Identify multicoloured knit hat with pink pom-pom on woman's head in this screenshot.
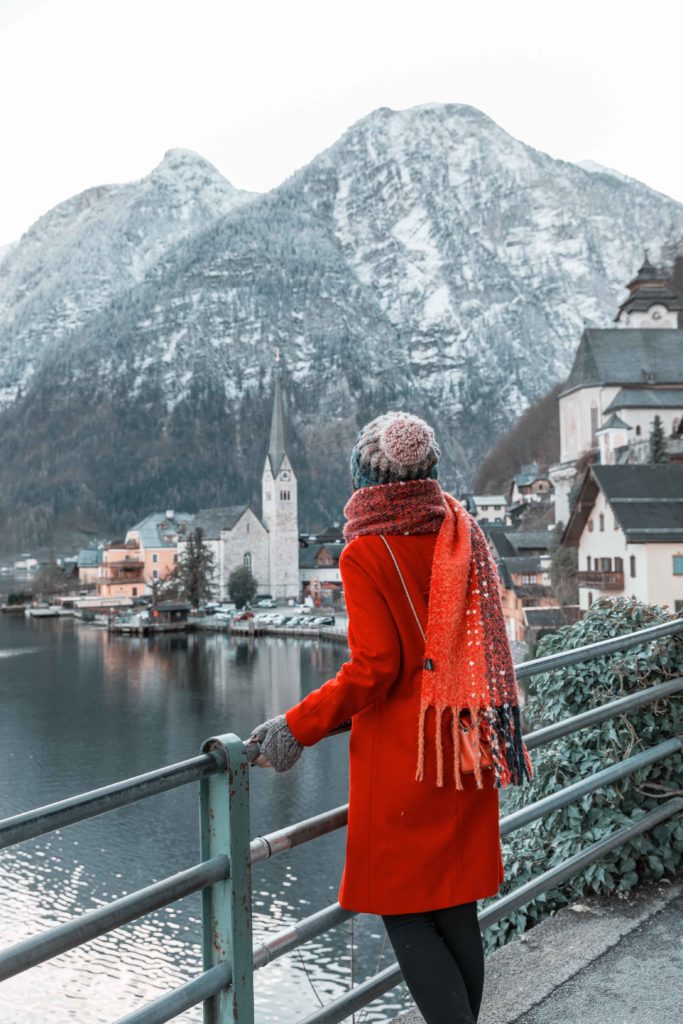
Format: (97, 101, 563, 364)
(350, 412, 440, 489)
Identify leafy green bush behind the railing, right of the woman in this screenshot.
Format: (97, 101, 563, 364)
(487, 598, 683, 946)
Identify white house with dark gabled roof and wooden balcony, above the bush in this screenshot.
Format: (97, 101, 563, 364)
(562, 463, 683, 611)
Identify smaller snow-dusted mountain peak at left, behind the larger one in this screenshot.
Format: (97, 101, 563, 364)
(0, 150, 252, 407)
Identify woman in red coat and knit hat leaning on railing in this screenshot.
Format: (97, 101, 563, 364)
(251, 413, 530, 1024)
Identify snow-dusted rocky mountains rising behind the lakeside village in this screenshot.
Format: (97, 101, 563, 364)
(0, 105, 683, 550)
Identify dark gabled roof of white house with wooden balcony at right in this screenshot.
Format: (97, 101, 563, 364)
(564, 463, 683, 544)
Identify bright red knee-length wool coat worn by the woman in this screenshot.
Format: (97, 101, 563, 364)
(286, 534, 503, 914)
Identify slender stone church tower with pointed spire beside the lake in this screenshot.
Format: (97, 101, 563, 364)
(261, 350, 299, 599)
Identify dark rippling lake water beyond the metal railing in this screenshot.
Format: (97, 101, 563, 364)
(0, 615, 410, 1024)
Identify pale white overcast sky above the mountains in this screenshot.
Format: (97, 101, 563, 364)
(0, 0, 683, 244)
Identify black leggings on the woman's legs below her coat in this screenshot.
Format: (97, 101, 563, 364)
(382, 902, 483, 1024)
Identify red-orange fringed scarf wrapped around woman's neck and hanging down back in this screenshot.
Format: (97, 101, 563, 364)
(344, 480, 532, 790)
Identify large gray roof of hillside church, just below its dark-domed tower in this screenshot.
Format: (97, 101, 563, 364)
(562, 328, 683, 394)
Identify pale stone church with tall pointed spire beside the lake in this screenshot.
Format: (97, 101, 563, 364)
(178, 356, 299, 600)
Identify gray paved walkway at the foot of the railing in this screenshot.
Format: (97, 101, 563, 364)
(396, 876, 683, 1024)
